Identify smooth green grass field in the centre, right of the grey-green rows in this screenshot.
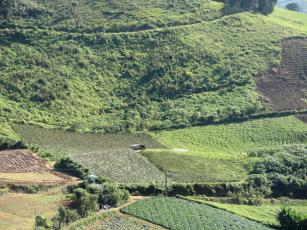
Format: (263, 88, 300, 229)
(142, 150, 250, 183)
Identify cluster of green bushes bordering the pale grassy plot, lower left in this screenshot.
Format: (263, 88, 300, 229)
(35, 177, 130, 229)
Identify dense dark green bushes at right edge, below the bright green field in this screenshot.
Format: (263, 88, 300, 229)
(248, 146, 307, 199)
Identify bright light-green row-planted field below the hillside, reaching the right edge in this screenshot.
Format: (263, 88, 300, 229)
(153, 116, 307, 157)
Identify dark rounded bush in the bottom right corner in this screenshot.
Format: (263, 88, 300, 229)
(278, 208, 307, 230)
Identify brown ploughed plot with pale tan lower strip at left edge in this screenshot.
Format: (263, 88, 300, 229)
(0, 150, 66, 184)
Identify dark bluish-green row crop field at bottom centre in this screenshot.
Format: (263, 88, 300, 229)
(122, 198, 270, 230)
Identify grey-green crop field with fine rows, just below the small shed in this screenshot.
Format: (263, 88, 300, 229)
(71, 150, 164, 183)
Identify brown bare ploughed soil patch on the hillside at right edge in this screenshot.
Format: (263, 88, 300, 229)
(256, 38, 307, 112)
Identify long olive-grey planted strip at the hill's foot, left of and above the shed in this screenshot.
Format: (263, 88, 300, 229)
(13, 125, 164, 157)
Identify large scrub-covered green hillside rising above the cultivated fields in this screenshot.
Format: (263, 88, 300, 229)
(0, 0, 307, 137)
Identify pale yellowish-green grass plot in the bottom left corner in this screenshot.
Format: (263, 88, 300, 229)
(0, 189, 65, 230)
